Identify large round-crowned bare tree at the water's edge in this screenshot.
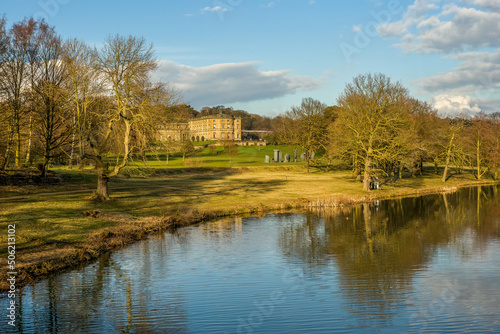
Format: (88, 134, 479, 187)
(336, 74, 412, 191)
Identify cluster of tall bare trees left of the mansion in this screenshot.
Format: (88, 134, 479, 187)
(0, 18, 180, 199)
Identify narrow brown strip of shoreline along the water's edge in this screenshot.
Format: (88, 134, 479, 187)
(0, 171, 499, 293)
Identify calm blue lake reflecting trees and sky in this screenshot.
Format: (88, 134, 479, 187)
(0, 187, 500, 333)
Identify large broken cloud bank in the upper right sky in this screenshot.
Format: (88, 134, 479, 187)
(377, 0, 500, 116)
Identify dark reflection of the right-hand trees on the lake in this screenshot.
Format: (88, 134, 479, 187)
(280, 187, 500, 329)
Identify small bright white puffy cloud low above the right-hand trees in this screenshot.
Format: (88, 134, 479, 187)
(432, 94, 481, 117)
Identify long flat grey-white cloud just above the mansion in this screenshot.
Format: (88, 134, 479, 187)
(155, 60, 324, 107)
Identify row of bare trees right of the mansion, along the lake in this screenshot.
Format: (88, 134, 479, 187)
(273, 73, 500, 191)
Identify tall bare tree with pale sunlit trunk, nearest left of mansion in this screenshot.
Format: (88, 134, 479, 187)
(85, 35, 160, 200)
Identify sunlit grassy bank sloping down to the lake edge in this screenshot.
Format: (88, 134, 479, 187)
(0, 164, 496, 290)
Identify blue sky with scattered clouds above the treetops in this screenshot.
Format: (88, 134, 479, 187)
(0, 0, 500, 117)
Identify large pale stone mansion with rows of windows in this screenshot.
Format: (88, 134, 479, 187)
(159, 114, 241, 141)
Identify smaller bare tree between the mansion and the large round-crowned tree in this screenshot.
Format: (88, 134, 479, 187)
(282, 98, 327, 173)
